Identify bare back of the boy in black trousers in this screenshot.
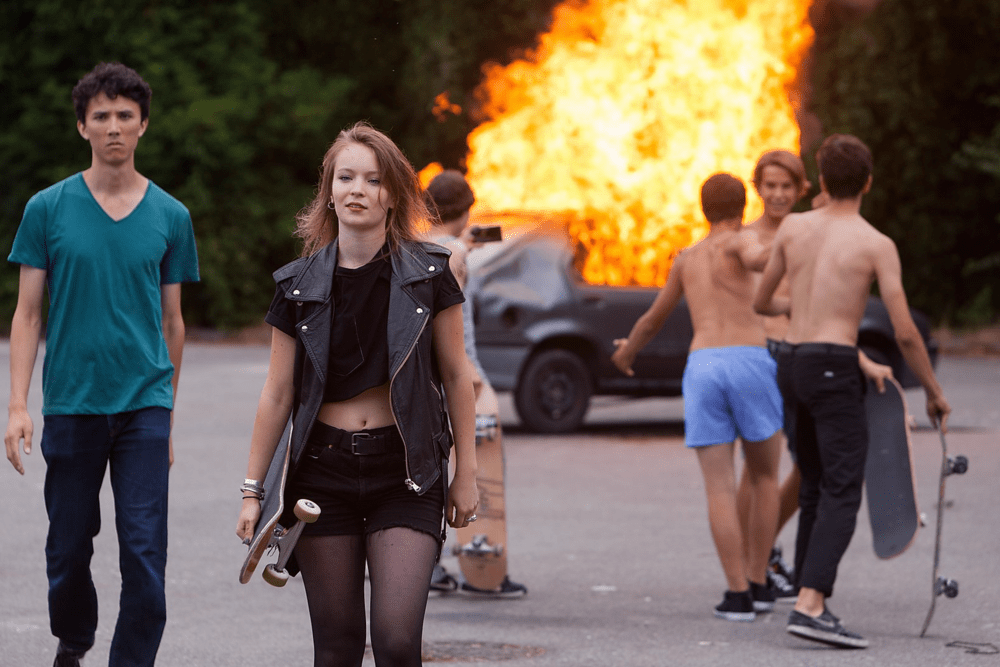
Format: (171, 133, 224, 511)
(777, 206, 894, 345)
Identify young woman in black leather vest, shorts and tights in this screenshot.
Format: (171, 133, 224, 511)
(236, 123, 479, 667)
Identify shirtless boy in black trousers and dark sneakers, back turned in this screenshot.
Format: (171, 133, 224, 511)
(754, 135, 951, 648)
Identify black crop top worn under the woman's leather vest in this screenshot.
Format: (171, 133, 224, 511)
(265, 244, 465, 403)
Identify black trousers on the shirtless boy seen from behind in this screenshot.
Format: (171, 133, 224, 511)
(778, 343, 868, 597)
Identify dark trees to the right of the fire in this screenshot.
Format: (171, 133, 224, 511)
(812, 0, 1000, 324)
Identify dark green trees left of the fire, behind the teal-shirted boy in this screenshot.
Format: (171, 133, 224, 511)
(0, 0, 556, 329)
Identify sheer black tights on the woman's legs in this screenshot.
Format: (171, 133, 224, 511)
(295, 527, 438, 667)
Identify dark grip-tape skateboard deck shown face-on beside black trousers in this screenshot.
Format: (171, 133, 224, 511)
(865, 379, 920, 558)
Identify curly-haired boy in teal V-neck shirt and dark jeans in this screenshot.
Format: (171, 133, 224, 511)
(4, 63, 198, 666)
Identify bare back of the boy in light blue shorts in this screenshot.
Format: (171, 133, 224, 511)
(678, 228, 766, 350)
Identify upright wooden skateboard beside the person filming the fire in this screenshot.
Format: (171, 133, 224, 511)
(453, 385, 507, 590)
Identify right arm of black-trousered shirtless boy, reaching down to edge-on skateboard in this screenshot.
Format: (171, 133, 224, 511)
(873, 238, 951, 432)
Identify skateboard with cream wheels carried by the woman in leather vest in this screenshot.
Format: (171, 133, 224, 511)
(240, 421, 320, 586)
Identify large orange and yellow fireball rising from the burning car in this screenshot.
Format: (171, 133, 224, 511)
(467, 0, 813, 285)
